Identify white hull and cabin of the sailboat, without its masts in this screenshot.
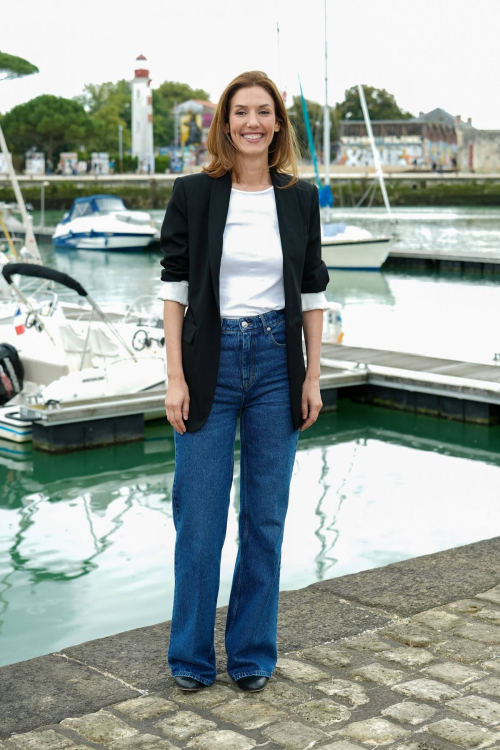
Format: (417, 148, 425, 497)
(321, 222, 392, 271)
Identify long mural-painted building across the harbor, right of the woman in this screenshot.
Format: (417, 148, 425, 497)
(334, 108, 475, 170)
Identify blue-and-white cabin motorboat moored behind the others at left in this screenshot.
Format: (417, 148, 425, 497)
(52, 195, 159, 250)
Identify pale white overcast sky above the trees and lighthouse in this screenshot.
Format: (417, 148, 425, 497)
(0, 0, 500, 129)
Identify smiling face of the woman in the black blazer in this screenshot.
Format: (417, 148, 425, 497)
(225, 86, 280, 155)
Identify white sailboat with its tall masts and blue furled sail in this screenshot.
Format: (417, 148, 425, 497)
(299, 0, 392, 271)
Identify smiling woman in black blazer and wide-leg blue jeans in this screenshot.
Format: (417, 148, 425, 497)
(159, 71, 329, 691)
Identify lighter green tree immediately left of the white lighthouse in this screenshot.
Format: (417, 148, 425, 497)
(74, 79, 132, 152)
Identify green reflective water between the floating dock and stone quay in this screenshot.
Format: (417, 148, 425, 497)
(0, 401, 500, 664)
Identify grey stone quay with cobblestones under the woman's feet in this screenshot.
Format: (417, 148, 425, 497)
(0, 537, 500, 750)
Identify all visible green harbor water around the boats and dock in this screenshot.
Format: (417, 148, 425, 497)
(0, 208, 500, 665)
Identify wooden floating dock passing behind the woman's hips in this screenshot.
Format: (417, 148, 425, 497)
(9, 343, 500, 453)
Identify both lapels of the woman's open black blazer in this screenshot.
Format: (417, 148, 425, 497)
(208, 168, 303, 310)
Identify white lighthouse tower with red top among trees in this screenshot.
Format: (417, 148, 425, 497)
(132, 55, 155, 173)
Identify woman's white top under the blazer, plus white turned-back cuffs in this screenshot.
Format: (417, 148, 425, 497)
(158, 186, 328, 318)
